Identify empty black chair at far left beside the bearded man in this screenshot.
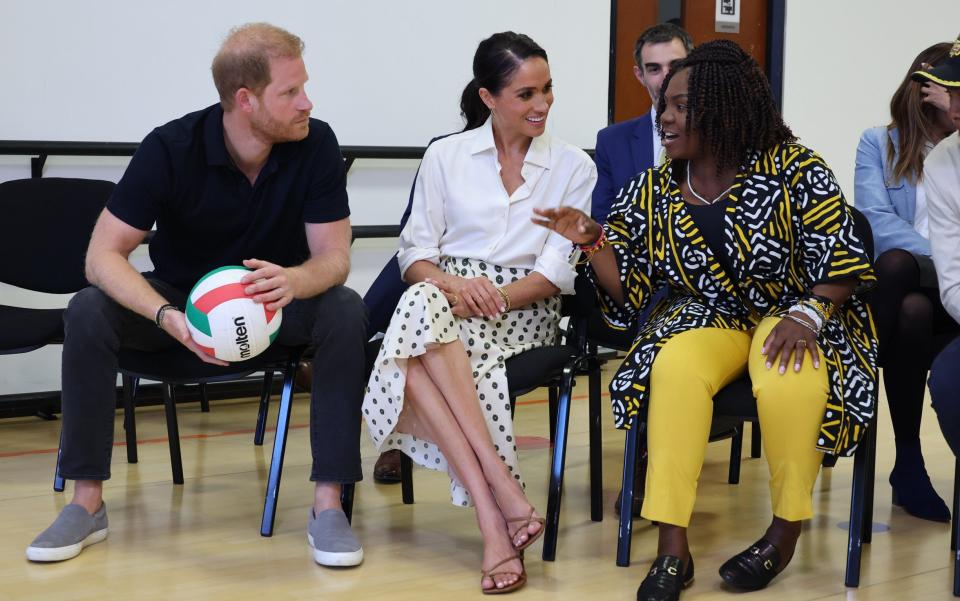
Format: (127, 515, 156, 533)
(0, 178, 114, 355)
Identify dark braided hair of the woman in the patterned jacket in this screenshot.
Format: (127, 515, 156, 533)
(657, 40, 797, 170)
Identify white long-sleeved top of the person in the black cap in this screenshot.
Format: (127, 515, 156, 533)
(923, 132, 960, 321)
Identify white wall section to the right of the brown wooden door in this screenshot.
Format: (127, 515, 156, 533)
(783, 0, 960, 203)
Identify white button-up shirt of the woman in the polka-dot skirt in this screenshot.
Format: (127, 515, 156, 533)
(397, 119, 597, 294)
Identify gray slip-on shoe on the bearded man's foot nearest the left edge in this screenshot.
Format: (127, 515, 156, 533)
(27, 503, 107, 561)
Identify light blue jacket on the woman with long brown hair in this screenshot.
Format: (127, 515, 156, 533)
(853, 127, 931, 257)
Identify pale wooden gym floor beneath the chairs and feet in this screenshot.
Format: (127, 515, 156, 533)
(0, 365, 953, 601)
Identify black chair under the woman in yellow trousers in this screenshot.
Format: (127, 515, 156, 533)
(617, 207, 876, 587)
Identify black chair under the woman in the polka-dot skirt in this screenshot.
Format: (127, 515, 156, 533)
(388, 276, 603, 561)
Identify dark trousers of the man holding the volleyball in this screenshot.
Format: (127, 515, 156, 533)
(60, 276, 367, 482)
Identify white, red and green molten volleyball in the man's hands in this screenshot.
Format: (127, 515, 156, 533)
(186, 265, 281, 361)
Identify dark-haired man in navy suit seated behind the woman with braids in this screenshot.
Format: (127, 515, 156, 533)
(590, 23, 693, 223)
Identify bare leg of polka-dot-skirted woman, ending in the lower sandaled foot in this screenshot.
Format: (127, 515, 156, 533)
(397, 357, 523, 588)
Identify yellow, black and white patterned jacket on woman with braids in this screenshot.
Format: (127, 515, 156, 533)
(598, 144, 877, 455)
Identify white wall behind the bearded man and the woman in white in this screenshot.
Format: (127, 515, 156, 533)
(0, 0, 610, 395)
